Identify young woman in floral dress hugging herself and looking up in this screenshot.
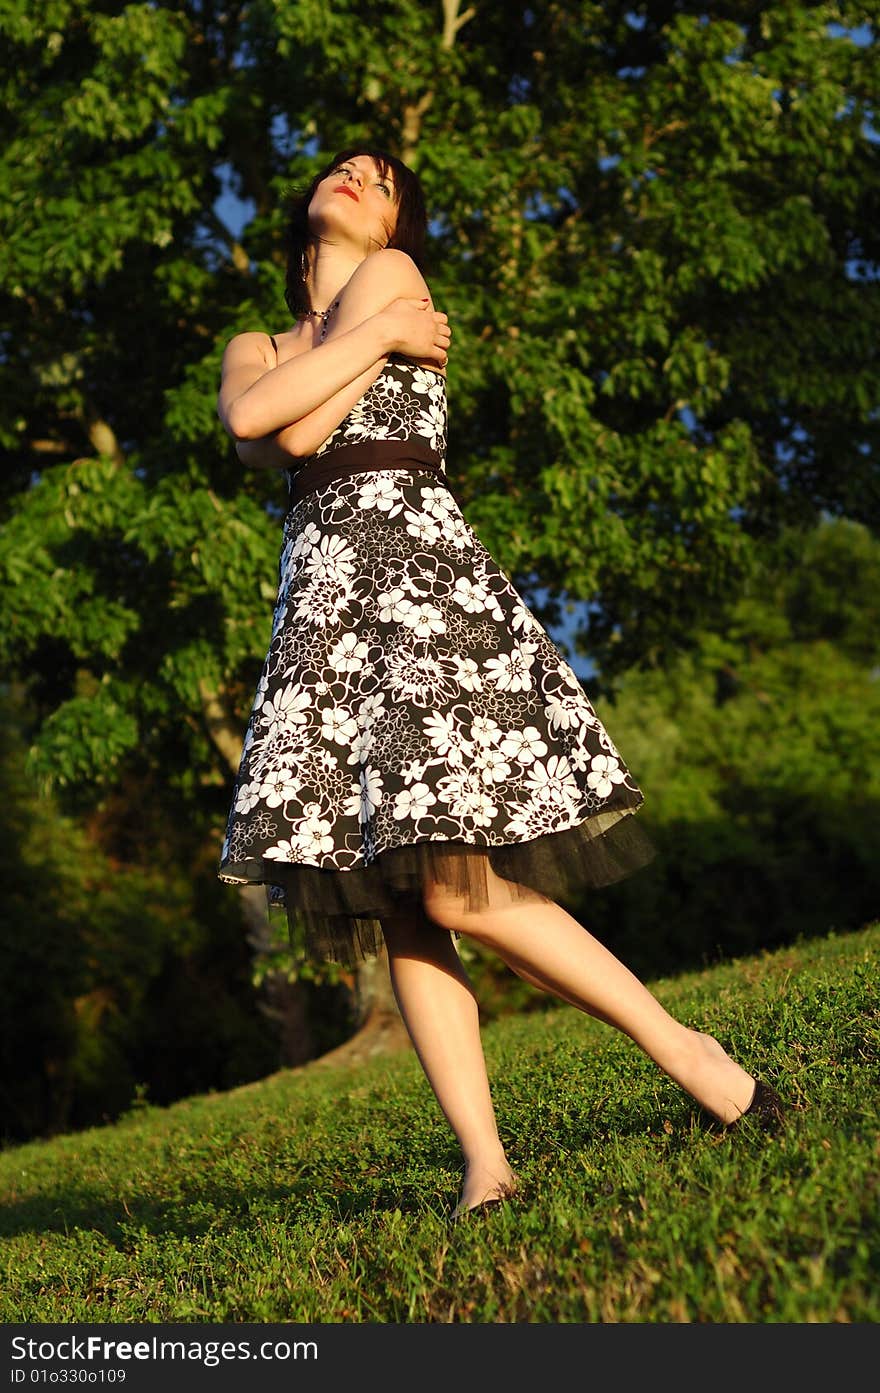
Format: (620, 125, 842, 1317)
(219, 148, 783, 1216)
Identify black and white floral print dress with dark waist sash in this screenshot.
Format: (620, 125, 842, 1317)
(219, 355, 654, 964)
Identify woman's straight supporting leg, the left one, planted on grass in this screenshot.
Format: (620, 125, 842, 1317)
(382, 910, 515, 1213)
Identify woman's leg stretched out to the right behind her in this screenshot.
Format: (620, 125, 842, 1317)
(425, 866, 755, 1123)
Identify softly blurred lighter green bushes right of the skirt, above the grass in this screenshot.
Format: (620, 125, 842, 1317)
(576, 521, 880, 972)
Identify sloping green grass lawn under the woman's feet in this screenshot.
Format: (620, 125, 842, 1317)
(0, 926, 880, 1323)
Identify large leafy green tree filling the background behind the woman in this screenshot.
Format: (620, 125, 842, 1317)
(0, 0, 880, 1058)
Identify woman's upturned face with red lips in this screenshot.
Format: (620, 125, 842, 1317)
(309, 155, 397, 255)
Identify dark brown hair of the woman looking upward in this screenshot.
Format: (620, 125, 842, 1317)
(284, 145, 427, 318)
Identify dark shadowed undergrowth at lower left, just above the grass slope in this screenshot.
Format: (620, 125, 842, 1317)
(0, 694, 277, 1142)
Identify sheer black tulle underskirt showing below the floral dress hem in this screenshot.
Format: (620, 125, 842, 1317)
(223, 795, 656, 967)
